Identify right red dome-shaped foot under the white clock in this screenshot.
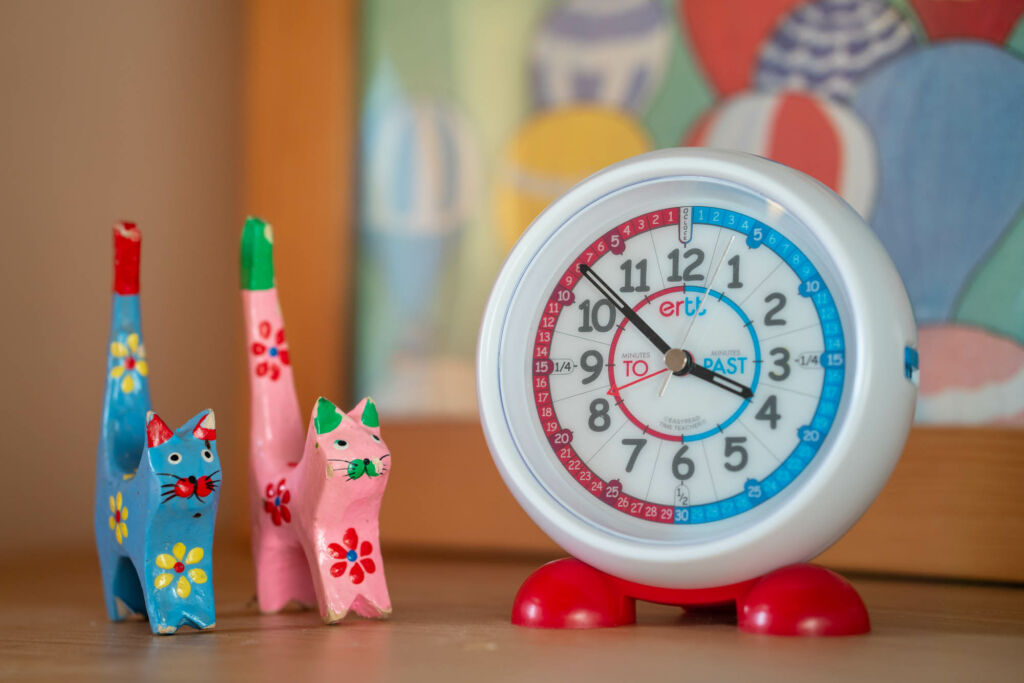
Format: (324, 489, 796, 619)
(736, 564, 871, 636)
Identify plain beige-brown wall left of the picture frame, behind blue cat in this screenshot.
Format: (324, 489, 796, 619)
(0, 0, 245, 557)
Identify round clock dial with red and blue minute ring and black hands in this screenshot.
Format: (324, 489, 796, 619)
(530, 205, 845, 524)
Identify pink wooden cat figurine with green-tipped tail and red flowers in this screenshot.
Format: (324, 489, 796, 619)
(241, 218, 391, 624)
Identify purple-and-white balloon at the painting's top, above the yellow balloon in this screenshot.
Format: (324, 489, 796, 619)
(529, 0, 673, 112)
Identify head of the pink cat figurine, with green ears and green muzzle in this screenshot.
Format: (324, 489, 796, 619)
(313, 396, 391, 481)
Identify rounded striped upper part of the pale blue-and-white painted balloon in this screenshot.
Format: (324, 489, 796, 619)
(362, 99, 480, 236)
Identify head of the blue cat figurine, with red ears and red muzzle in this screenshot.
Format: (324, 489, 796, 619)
(145, 411, 220, 509)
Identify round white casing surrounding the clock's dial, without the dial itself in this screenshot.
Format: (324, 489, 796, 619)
(477, 148, 916, 589)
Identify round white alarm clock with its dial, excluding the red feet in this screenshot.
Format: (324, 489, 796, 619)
(477, 148, 916, 589)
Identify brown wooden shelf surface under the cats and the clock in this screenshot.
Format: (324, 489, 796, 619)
(0, 548, 1024, 683)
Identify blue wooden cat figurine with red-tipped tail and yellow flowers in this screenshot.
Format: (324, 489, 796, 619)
(95, 223, 220, 634)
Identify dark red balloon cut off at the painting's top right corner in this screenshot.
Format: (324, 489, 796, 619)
(910, 0, 1024, 45)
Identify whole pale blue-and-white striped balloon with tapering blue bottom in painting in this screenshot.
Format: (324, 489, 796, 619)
(361, 98, 481, 345)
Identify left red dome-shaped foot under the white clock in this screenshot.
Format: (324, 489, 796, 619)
(512, 558, 636, 629)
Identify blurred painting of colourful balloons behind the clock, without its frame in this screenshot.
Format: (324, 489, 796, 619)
(354, 0, 1024, 425)
